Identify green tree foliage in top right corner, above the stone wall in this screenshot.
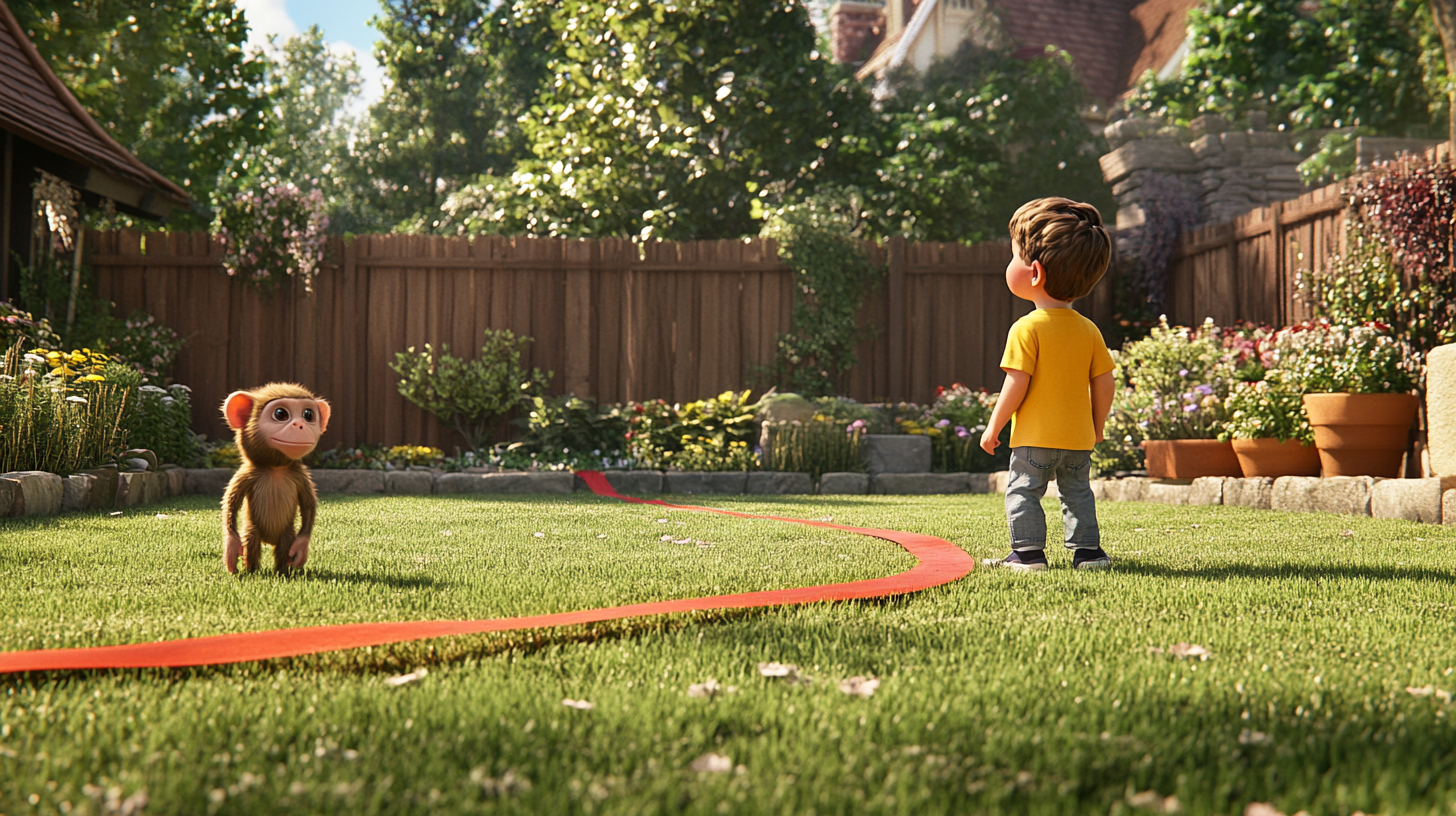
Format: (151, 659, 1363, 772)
(1130, 0, 1447, 136)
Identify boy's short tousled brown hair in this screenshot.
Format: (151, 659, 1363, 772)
(1010, 197, 1112, 300)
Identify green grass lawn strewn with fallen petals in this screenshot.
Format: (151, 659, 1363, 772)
(0, 494, 1456, 816)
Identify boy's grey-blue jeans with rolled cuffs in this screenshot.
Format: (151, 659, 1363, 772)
(1006, 446, 1102, 551)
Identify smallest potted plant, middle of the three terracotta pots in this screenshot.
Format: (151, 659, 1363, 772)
(1219, 369, 1319, 478)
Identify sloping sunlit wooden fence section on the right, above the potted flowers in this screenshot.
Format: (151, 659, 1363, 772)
(1166, 143, 1450, 326)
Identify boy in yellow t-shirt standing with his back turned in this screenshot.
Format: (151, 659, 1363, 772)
(981, 198, 1112, 570)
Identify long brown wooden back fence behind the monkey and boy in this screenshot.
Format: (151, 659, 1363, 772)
(84, 232, 1111, 450)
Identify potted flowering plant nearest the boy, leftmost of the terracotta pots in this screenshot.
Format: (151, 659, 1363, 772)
(1108, 318, 1241, 479)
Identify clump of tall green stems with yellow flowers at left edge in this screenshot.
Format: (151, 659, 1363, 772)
(0, 341, 128, 475)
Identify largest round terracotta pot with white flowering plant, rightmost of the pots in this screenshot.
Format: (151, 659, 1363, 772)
(1273, 321, 1420, 476)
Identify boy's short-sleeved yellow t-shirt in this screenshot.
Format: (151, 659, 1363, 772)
(1000, 309, 1112, 450)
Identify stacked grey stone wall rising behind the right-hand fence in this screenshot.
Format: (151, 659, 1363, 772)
(1102, 115, 1318, 230)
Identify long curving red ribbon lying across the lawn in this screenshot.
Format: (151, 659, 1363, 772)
(0, 471, 976, 673)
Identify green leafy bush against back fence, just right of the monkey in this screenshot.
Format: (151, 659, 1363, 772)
(390, 329, 550, 450)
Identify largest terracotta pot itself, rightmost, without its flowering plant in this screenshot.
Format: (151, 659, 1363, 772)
(1305, 393, 1420, 478)
